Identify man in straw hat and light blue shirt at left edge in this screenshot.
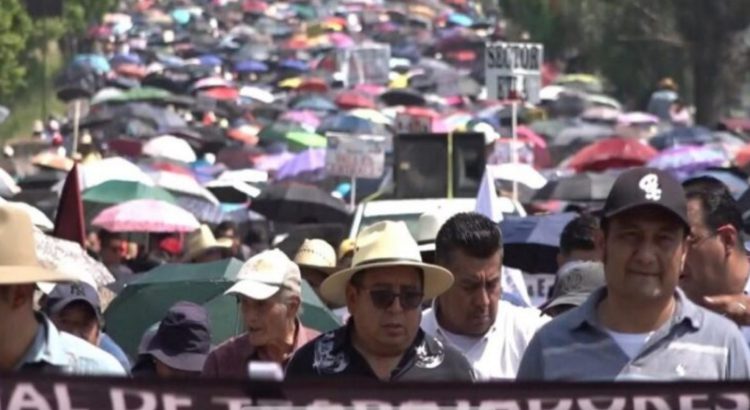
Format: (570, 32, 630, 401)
(0, 206, 125, 375)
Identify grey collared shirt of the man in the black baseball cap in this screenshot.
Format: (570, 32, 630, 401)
(518, 288, 750, 381)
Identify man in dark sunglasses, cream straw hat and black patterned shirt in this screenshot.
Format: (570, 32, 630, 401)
(286, 221, 474, 381)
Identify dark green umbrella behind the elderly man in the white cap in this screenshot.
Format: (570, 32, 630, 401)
(104, 259, 242, 356)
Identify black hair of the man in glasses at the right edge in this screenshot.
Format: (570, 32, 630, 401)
(682, 176, 743, 246)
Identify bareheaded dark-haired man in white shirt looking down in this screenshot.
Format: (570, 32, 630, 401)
(422, 213, 549, 380)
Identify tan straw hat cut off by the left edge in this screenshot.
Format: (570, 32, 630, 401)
(0, 204, 76, 285)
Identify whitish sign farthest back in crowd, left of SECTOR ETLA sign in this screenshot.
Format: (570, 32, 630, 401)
(336, 43, 391, 87)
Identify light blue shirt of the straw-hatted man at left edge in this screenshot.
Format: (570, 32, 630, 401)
(16, 313, 127, 376)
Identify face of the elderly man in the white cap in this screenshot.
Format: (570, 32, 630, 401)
(240, 293, 297, 347)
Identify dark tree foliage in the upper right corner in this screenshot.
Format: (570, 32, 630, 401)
(500, 0, 750, 124)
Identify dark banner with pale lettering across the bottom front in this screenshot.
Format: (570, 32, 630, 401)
(0, 374, 750, 410)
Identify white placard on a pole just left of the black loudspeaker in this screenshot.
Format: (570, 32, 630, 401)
(326, 133, 386, 178)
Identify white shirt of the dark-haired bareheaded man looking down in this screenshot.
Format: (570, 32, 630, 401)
(421, 301, 550, 380)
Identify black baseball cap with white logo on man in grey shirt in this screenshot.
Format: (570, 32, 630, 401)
(602, 167, 690, 232)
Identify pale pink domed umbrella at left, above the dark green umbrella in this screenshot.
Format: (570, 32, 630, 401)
(91, 199, 200, 232)
